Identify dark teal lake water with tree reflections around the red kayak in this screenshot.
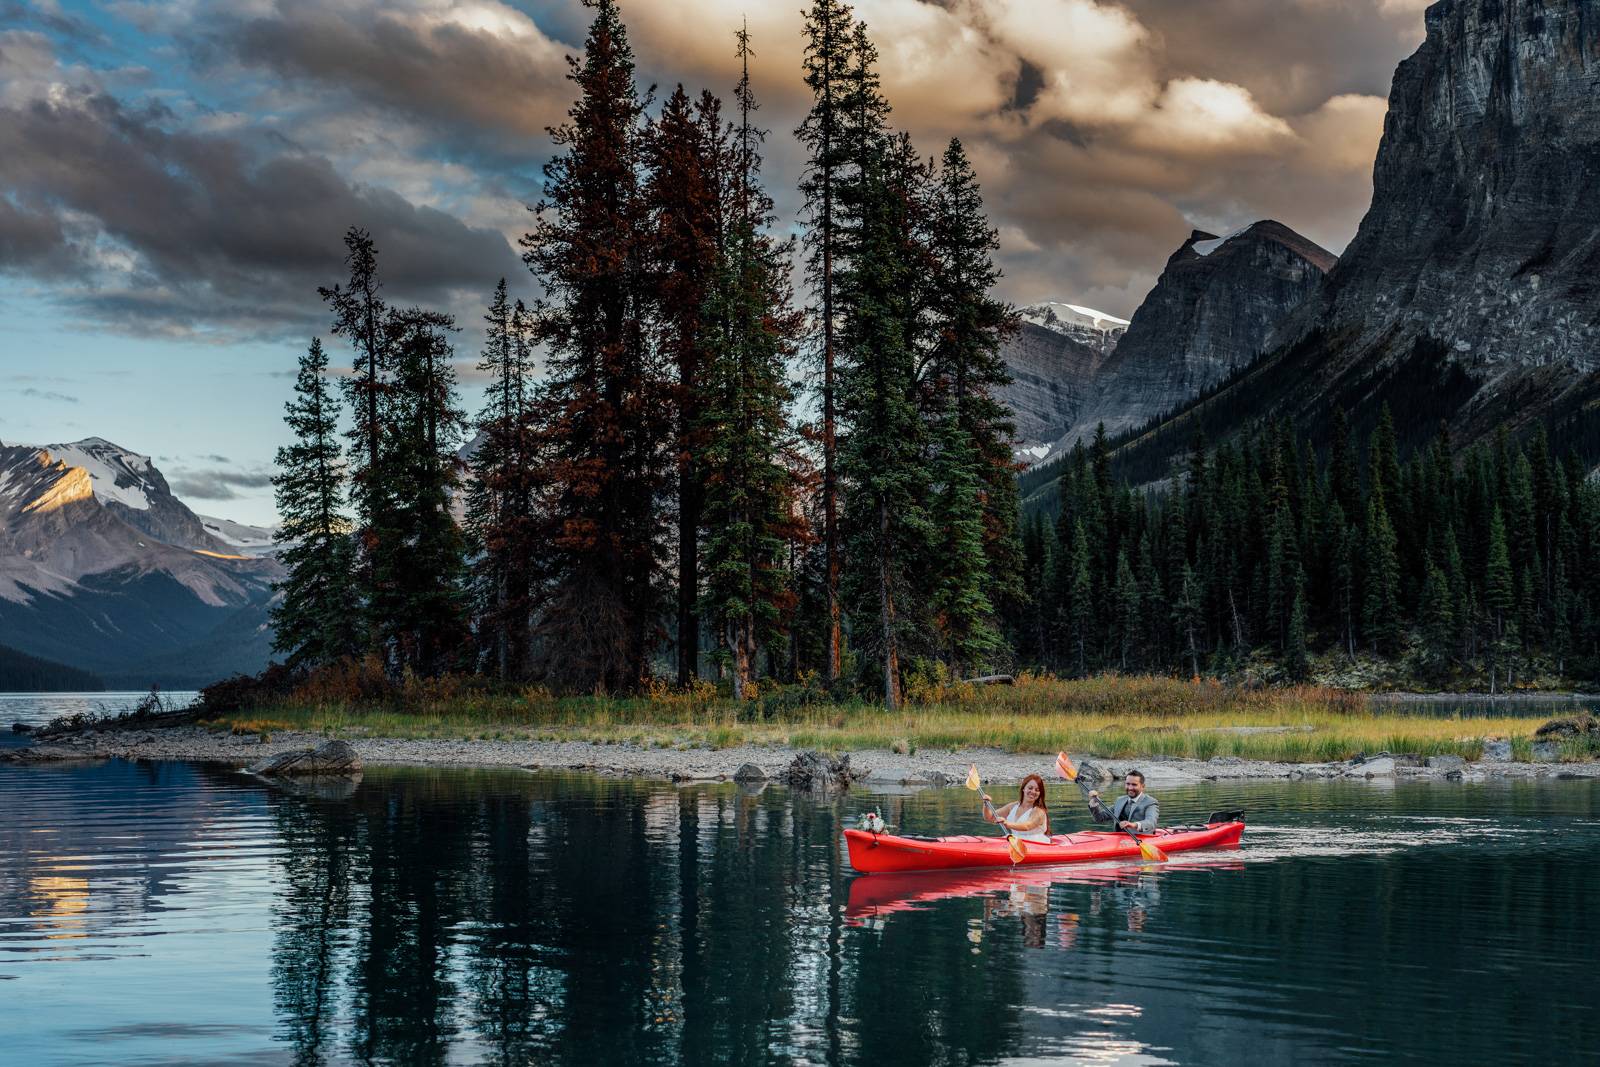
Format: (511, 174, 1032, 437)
(0, 700, 1600, 1065)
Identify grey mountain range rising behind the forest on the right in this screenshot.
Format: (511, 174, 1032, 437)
(1006, 0, 1600, 483)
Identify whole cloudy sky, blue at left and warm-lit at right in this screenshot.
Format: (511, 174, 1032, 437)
(0, 0, 1426, 522)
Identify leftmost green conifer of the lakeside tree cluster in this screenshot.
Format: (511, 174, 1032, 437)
(272, 338, 363, 667)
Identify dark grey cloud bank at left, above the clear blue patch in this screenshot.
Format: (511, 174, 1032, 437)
(0, 35, 518, 336)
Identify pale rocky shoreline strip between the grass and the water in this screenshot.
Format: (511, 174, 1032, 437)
(12, 726, 1600, 789)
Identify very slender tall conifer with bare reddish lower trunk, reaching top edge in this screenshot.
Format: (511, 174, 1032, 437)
(795, 0, 853, 681)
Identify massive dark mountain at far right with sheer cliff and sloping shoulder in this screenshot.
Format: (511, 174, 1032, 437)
(1118, 0, 1600, 480)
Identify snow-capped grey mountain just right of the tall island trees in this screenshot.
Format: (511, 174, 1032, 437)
(998, 302, 1128, 459)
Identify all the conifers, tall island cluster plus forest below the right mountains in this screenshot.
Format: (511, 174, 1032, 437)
(275, 0, 1600, 707)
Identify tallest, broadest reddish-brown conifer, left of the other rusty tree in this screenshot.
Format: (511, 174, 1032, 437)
(522, 0, 674, 693)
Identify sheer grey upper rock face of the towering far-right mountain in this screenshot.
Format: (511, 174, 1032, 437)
(1320, 0, 1600, 381)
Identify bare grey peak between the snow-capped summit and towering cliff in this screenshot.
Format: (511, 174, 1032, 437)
(1061, 219, 1336, 446)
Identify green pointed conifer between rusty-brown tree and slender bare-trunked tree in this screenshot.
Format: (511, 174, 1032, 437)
(698, 29, 800, 699)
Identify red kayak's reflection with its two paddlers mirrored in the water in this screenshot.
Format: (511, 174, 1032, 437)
(845, 859, 1245, 949)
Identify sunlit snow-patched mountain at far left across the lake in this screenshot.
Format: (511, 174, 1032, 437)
(0, 438, 282, 688)
